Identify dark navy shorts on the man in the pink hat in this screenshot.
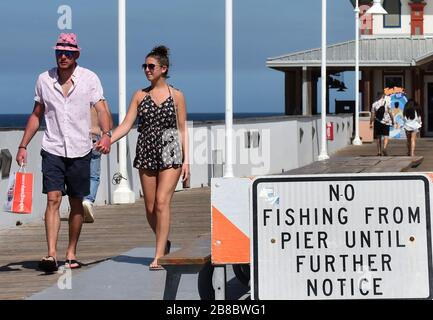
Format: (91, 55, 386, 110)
(41, 150, 92, 198)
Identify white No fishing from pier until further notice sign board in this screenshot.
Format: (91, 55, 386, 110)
(251, 174, 432, 300)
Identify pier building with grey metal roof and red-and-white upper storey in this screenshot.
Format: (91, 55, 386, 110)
(266, 0, 433, 136)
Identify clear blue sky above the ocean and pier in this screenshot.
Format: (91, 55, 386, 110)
(0, 0, 354, 113)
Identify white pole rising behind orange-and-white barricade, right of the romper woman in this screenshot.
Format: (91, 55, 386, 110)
(224, 0, 234, 178)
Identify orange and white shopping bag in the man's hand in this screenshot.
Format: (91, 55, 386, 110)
(5, 166, 33, 214)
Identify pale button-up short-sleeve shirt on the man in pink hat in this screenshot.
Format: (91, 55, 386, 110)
(35, 66, 104, 158)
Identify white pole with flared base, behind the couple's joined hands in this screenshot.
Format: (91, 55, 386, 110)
(113, 0, 135, 203)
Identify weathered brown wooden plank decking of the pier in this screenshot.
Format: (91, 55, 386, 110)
(0, 138, 433, 299)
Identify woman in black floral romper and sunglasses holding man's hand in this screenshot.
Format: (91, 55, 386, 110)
(107, 46, 190, 270)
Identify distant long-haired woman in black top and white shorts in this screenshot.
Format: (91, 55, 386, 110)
(403, 99, 422, 157)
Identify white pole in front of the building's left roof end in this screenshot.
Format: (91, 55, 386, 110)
(318, 0, 329, 161)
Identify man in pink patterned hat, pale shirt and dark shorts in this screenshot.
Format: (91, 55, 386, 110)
(16, 33, 111, 272)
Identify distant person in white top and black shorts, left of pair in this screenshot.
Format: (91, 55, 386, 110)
(370, 95, 394, 156)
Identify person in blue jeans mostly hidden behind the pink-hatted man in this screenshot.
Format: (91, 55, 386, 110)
(83, 101, 113, 223)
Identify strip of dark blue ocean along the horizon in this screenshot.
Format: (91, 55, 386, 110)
(0, 113, 284, 128)
